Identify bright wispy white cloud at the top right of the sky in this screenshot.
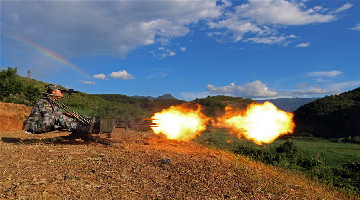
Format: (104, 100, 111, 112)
(208, 0, 336, 46)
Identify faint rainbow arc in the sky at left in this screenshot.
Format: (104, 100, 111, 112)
(5, 35, 91, 79)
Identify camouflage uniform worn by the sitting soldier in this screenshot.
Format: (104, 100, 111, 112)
(24, 97, 81, 133)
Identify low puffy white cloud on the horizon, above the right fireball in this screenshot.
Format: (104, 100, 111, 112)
(206, 80, 278, 98)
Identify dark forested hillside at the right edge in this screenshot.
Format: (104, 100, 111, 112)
(294, 88, 360, 138)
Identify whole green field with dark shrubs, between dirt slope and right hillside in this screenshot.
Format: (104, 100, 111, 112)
(193, 129, 360, 193)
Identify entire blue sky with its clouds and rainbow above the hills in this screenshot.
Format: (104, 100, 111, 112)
(0, 0, 360, 100)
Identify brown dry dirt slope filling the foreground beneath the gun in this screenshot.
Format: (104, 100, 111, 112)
(0, 102, 351, 199)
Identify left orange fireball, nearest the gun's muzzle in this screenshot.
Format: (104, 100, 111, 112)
(151, 105, 209, 141)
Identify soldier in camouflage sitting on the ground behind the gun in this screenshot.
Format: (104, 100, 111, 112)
(23, 84, 95, 135)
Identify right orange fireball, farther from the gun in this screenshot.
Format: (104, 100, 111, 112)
(216, 102, 295, 145)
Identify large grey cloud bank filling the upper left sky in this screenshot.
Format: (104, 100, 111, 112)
(1, 0, 228, 60)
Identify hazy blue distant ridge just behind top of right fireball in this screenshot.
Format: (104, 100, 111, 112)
(256, 98, 318, 112)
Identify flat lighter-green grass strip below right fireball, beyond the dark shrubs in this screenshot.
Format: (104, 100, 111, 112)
(194, 129, 360, 167)
